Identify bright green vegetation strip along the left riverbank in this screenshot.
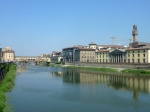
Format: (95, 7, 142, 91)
(0, 65, 16, 112)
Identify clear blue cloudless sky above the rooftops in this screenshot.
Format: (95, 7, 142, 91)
(0, 0, 150, 56)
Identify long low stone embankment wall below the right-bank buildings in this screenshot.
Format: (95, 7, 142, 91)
(66, 62, 150, 69)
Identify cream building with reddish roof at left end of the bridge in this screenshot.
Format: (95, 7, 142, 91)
(2, 47, 15, 62)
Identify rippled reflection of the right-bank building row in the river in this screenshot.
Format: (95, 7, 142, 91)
(63, 70, 150, 99)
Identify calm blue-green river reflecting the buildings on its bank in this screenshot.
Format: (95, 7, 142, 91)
(7, 66, 150, 112)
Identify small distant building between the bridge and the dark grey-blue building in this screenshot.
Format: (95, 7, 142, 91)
(51, 51, 63, 63)
